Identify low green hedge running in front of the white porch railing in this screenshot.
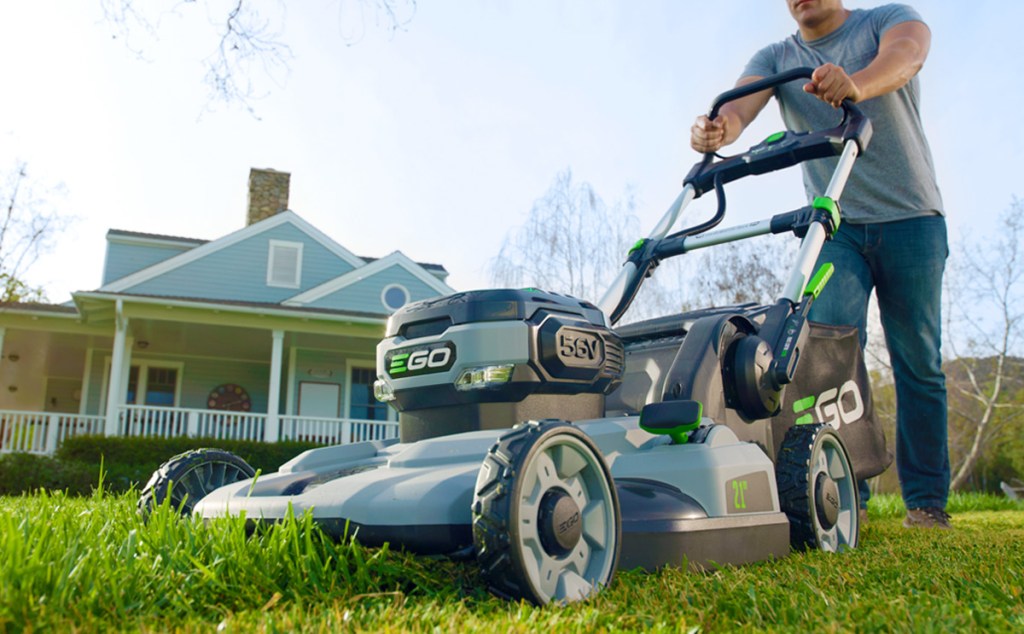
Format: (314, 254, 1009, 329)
(0, 436, 321, 495)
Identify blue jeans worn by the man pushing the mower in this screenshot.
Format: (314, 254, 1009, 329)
(810, 216, 949, 509)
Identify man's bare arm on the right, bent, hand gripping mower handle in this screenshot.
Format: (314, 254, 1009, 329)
(804, 22, 932, 108)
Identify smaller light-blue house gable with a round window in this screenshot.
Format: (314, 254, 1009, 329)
(284, 251, 455, 314)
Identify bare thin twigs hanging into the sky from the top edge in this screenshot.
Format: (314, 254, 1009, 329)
(100, 0, 416, 113)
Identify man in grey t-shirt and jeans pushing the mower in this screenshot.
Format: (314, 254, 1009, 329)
(690, 0, 950, 529)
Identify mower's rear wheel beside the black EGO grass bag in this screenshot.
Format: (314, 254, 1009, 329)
(775, 424, 860, 552)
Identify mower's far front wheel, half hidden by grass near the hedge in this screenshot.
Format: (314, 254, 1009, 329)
(138, 449, 256, 517)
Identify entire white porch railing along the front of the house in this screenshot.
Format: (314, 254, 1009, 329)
(0, 406, 398, 454)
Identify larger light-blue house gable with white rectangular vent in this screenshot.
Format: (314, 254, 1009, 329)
(100, 211, 364, 303)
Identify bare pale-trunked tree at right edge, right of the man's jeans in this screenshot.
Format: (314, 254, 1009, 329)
(946, 199, 1024, 489)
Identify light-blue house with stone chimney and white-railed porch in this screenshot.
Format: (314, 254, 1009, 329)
(0, 169, 453, 453)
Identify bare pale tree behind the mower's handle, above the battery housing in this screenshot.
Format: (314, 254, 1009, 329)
(490, 169, 797, 322)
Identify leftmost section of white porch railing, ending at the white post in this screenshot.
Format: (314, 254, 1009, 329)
(0, 410, 103, 454)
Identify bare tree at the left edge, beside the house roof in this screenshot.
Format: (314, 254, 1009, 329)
(0, 163, 68, 302)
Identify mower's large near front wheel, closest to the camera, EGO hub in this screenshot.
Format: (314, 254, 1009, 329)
(473, 420, 622, 605)
